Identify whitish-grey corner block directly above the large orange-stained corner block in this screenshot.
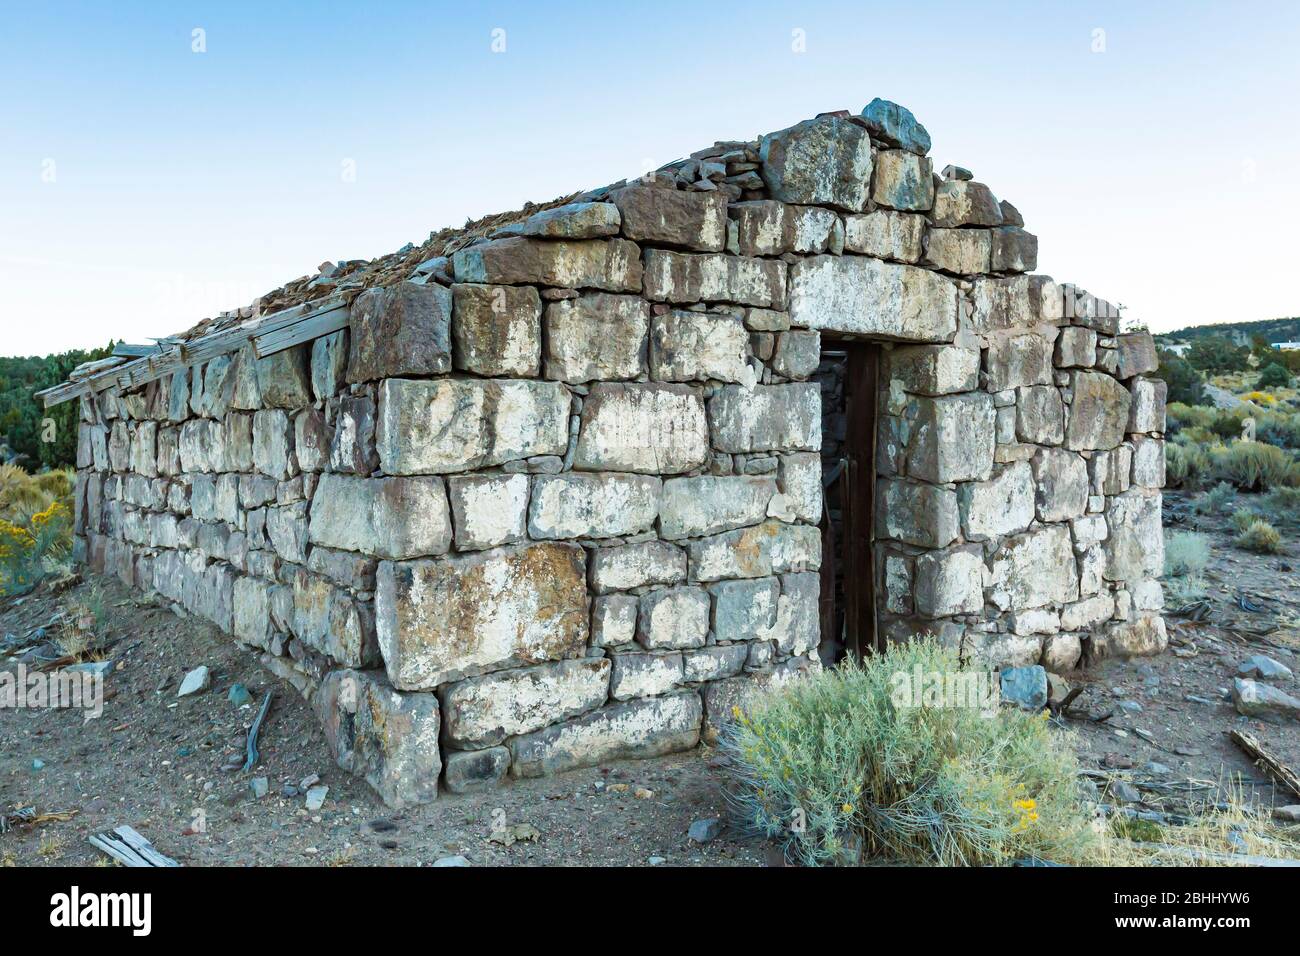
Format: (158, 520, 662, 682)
(309, 475, 451, 561)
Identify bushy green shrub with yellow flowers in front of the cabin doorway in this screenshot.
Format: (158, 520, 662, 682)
(722, 641, 1095, 865)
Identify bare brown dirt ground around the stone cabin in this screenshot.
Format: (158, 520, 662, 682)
(0, 496, 1300, 866)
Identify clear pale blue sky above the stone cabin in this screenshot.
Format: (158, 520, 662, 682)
(0, 0, 1300, 354)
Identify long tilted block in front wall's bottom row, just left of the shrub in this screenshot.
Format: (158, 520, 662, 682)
(510, 691, 703, 777)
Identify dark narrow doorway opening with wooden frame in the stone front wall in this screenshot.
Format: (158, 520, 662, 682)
(815, 338, 880, 665)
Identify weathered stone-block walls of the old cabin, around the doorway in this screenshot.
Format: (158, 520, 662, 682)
(68, 100, 1165, 805)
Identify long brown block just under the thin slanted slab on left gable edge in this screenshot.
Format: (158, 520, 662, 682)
(451, 237, 641, 293)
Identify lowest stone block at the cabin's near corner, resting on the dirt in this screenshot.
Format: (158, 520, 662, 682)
(314, 671, 442, 809)
